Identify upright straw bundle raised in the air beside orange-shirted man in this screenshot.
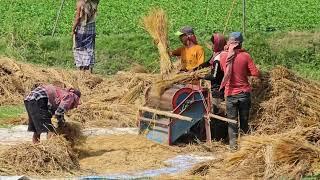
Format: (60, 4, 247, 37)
(143, 9, 172, 74)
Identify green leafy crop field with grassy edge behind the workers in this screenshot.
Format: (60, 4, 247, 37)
(0, 0, 320, 79)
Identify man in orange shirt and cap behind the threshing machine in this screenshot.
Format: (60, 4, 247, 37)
(170, 26, 204, 71)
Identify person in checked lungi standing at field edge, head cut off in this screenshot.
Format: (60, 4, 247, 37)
(72, 0, 99, 73)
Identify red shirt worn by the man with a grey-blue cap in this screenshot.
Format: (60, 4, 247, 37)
(220, 50, 259, 96)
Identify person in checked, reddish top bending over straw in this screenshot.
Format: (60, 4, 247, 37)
(24, 84, 81, 143)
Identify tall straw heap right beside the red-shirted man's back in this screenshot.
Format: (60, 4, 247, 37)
(252, 66, 320, 134)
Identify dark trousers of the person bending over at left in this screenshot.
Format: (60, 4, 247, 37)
(24, 98, 54, 134)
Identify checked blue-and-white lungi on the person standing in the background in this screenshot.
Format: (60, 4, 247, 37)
(73, 22, 96, 68)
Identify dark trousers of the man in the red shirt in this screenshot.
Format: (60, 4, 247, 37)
(226, 93, 251, 149)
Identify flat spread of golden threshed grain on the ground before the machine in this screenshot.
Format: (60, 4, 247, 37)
(80, 135, 178, 173)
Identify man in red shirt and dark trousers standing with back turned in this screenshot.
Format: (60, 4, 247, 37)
(220, 32, 259, 150)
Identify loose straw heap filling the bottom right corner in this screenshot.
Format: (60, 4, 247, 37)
(192, 127, 320, 179)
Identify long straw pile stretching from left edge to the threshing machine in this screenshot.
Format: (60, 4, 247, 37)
(0, 59, 157, 127)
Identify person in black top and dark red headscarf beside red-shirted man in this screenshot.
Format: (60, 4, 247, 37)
(194, 33, 226, 113)
